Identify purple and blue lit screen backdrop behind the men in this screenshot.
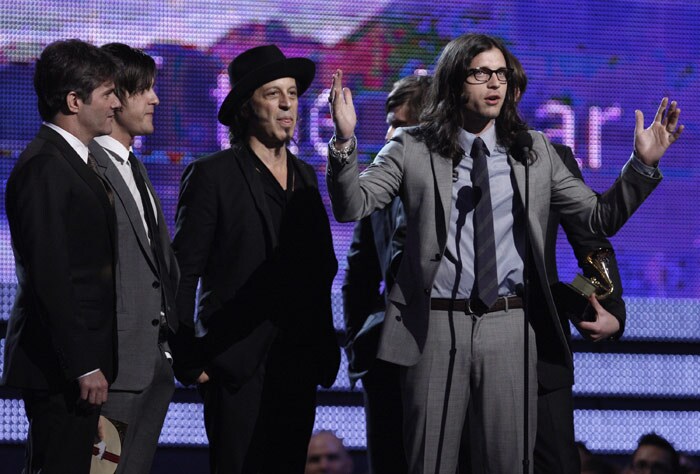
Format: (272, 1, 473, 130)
(0, 0, 700, 452)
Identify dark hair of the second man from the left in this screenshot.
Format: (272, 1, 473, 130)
(100, 43, 156, 102)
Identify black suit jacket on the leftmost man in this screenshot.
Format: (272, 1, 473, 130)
(3, 126, 117, 389)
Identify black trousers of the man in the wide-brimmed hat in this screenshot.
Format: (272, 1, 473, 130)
(199, 343, 316, 474)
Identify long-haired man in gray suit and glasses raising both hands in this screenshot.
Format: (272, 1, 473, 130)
(327, 34, 683, 474)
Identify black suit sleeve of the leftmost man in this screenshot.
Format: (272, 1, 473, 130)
(8, 155, 101, 380)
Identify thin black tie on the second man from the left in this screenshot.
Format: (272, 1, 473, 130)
(129, 152, 178, 332)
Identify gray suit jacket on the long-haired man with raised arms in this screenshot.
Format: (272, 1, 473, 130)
(327, 129, 660, 367)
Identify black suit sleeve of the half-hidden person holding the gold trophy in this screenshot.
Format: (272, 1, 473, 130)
(555, 146, 627, 339)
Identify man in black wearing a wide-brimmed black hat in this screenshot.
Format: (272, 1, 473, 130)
(173, 45, 340, 473)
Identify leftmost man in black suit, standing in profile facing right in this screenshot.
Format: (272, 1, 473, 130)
(3, 40, 120, 473)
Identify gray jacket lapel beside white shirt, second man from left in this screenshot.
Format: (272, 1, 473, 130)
(90, 141, 156, 270)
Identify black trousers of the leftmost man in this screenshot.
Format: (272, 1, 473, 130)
(22, 382, 100, 474)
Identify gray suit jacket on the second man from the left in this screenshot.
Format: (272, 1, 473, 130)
(89, 142, 178, 391)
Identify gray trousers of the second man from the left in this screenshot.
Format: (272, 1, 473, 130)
(102, 353, 175, 474)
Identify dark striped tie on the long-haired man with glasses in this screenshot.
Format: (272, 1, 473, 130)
(470, 137, 498, 308)
